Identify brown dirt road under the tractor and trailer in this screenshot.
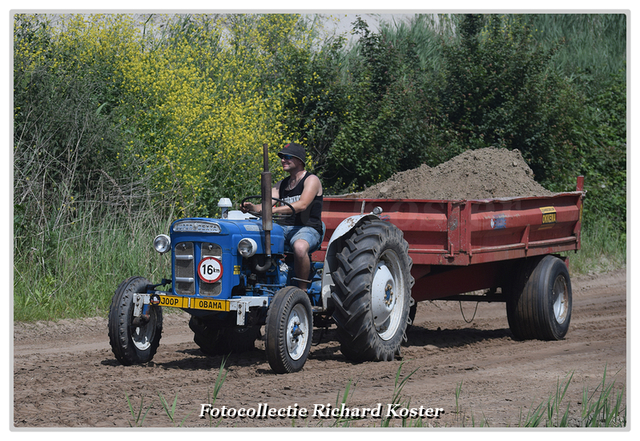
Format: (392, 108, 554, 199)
(13, 271, 627, 428)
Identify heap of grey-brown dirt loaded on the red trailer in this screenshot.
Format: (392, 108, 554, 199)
(357, 147, 553, 200)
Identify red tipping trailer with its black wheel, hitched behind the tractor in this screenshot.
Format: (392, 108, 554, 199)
(313, 177, 584, 339)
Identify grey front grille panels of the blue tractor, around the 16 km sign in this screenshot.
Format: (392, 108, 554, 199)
(174, 242, 222, 296)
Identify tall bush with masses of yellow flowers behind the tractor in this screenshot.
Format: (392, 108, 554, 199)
(15, 14, 320, 215)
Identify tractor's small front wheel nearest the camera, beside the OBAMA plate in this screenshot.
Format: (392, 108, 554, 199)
(265, 286, 313, 374)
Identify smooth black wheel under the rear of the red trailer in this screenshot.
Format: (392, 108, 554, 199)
(507, 255, 572, 340)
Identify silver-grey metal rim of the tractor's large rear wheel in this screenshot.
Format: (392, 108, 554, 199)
(371, 250, 404, 340)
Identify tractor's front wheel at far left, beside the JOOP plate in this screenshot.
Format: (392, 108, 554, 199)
(108, 277, 162, 366)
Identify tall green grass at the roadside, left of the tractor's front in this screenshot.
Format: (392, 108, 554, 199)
(13, 210, 171, 321)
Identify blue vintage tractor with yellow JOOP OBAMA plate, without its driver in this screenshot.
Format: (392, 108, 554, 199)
(108, 146, 413, 373)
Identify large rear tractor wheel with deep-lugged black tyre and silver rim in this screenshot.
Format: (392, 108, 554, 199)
(332, 219, 413, 361)
